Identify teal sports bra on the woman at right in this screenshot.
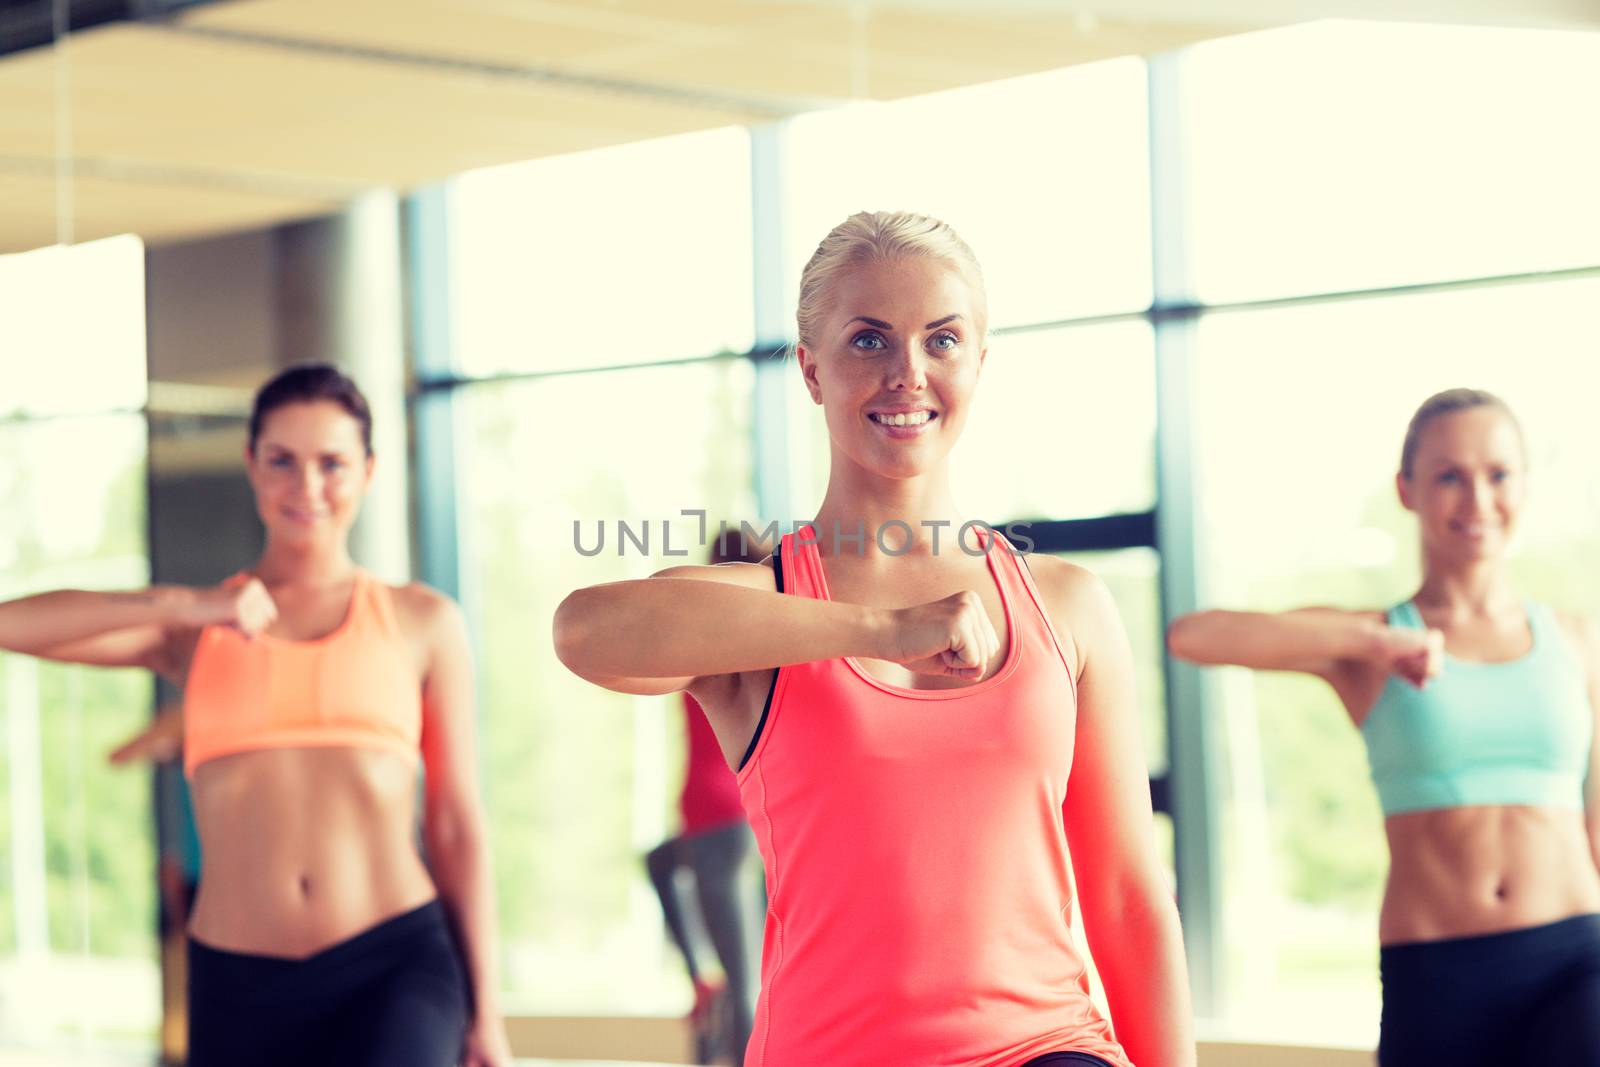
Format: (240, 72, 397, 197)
(1362, 601, 1595, 816)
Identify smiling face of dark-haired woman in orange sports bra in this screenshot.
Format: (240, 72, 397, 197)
(245, 400, 373, 544)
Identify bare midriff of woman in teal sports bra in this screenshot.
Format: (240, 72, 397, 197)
(1378, 806, 1600, 945)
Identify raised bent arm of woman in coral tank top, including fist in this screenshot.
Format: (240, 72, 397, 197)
(555, 563, 998, 694)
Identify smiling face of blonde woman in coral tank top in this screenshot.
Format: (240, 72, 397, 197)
(797, 256, 987, 478)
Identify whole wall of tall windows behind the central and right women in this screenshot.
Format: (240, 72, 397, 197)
(422, 24, 1600, 1043)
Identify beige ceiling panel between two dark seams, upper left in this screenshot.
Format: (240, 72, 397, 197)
(0, 26, 757, 188)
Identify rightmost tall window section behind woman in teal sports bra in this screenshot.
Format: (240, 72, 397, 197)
(1177, 22, 1600, 1045)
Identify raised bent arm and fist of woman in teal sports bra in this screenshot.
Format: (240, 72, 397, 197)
(1166, 608, 1445, 685)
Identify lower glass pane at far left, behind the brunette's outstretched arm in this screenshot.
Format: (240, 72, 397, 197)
(0, 416, 160, 1051)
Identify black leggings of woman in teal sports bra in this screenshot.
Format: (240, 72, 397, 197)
(1378, 915, 1600, 1067)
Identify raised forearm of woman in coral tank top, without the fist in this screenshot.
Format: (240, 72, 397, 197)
(555, 577, 888, 678)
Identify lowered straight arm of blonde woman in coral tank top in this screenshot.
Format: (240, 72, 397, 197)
(1030, 558, 1195, 1067)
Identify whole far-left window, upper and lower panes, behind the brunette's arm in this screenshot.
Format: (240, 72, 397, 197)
(0, 238, 160, 1059)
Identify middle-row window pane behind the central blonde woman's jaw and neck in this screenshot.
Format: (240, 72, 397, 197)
(787, 320, 1155, 525)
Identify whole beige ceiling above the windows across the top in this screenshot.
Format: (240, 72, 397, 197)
(0, 0, 1600, 251)
